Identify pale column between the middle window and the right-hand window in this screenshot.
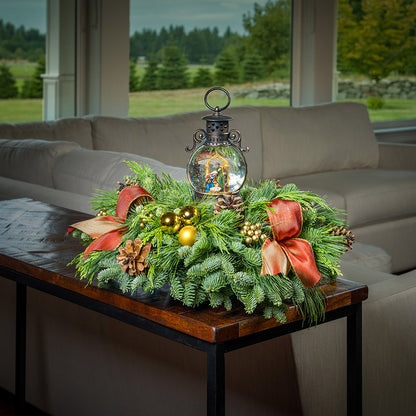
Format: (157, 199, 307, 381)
(292, 0, 337, 106)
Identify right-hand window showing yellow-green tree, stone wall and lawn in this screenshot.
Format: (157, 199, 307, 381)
(337, 0, 416, 122)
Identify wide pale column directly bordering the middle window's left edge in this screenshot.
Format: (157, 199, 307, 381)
(76, 0, 130, 117)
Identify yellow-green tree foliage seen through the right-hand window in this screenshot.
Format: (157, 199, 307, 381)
(338, 0, 416, 82)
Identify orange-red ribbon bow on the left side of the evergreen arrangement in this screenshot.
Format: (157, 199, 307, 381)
(68, 186, 153, 259)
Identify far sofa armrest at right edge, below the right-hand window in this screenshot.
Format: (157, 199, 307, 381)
(379, 143, 416, 170)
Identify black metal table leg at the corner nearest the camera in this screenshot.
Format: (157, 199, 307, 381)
(207, 344, 225, 416)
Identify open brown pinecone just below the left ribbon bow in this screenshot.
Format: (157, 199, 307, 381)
(116, 238, 152, 276)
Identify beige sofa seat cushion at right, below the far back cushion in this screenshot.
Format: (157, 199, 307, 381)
(282, 169, 416, 227)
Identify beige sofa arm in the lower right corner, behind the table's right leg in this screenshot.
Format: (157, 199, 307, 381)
(291, 262, 416, 416)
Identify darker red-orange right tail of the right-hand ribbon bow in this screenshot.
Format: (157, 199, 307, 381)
(280, 238, 321, 287)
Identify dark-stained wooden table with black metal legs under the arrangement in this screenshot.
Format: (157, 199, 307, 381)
(0, 198, 368, 416)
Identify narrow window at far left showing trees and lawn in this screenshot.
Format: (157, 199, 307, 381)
(0, 0, 46, 122)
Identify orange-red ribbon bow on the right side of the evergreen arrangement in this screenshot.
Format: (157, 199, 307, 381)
(261, 198, 321, 287)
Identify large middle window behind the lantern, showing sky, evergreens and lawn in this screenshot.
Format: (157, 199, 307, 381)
(129, 0, 291, 116)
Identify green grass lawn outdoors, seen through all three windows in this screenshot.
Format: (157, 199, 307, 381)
(0, 88, 416, 123)
